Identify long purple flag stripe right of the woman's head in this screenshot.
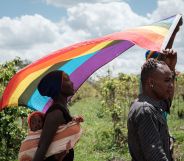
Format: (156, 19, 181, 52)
(70, 40, 134, 90)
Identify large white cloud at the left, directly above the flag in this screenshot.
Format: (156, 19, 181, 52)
(0, 15, 90, 62)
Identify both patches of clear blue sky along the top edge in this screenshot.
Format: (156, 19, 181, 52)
(0, 0, 157, 21)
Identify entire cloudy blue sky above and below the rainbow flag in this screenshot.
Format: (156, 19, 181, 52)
(0, 0, 184, 74)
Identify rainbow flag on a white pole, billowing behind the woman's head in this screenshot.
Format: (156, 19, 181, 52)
(0, 14, 182, 112)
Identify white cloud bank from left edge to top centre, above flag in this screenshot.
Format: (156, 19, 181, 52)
(0, 2, 146, 62)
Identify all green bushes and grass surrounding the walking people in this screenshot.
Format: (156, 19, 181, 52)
(0, 58, 184, 161)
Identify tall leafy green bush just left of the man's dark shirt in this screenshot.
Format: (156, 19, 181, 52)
(101, 71, 138, 149)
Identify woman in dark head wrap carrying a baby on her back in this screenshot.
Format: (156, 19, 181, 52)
(33, 71, 83, 161)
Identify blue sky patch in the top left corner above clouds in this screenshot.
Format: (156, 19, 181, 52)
(0, 0, 66, 21)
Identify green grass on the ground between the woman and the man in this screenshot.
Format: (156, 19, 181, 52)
(70, 98, 130, 161)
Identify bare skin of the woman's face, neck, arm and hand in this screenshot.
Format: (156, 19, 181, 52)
(33, 73, 84, 161)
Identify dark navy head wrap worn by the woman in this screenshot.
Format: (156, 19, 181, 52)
(38, 70, 63, 98)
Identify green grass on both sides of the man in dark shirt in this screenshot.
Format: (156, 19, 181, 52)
(70, 97, 184, 161)
